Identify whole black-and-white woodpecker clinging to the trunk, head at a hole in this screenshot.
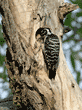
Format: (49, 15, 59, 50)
(35, 28, 60, 79)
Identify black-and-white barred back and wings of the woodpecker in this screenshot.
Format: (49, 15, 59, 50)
(44, 34, 60, 70)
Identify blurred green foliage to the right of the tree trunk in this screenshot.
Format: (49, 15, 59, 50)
(63, 0, 82, 84)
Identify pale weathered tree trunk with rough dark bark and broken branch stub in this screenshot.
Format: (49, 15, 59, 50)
(0, 0, 82, 110)
